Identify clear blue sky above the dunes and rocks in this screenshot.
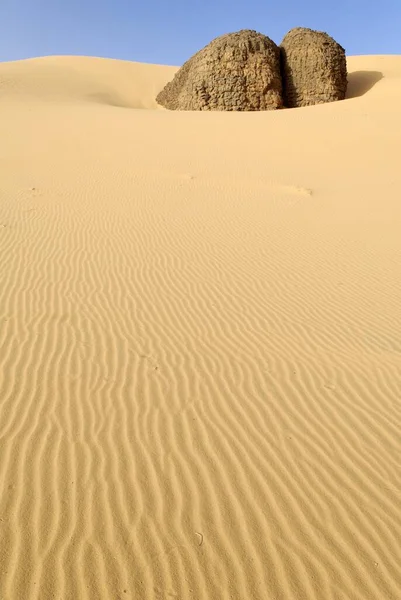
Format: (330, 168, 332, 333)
(0, 0, 401, 65)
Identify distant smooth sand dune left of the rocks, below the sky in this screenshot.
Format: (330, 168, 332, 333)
(0, 56, 177, 109)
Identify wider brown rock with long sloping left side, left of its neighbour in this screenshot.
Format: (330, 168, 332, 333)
(156, 29, 283, 111)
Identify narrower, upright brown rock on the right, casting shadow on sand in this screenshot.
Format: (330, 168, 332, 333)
(280, 27, 347, 108)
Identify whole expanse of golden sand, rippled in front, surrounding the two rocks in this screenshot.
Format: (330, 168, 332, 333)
(0, 56, 401, 600)
